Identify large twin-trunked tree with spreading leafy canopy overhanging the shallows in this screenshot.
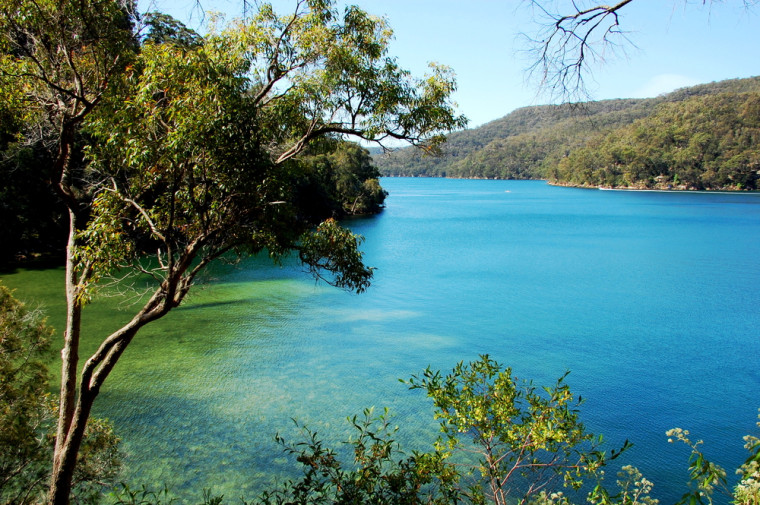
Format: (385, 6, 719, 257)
(0, 0, 465, 505)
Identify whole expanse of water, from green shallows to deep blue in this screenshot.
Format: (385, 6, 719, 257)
(3, 179, 760, 503)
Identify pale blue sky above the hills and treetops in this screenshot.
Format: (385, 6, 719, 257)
(140, 0, 760, 128)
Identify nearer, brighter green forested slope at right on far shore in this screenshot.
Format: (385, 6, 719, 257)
(553, 93, 760, 189)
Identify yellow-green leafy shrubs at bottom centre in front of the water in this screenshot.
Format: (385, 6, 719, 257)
(249, 356, 628, 505)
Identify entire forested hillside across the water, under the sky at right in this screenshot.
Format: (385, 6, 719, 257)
(375, 78, 760, 189)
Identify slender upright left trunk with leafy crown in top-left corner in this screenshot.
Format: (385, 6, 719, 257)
(0, 0, 135, 503)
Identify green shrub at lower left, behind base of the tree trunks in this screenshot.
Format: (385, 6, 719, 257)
(0, 285, 120, 505)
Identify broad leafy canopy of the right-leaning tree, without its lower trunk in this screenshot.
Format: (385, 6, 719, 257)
(74, 2, 461, 296)
